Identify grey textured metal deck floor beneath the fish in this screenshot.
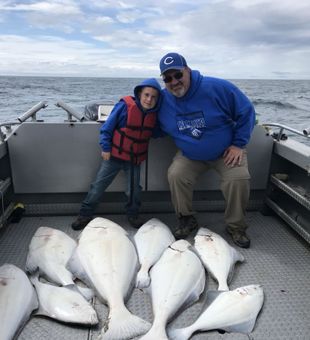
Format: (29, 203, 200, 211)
(0, 212, 310, 340)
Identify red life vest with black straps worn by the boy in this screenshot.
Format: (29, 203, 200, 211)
(111, 96, 156, 164)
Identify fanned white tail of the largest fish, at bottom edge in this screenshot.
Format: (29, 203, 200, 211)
(98, 307, 151, 340)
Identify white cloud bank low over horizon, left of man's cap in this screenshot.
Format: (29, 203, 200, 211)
(0, 35, 159, 77)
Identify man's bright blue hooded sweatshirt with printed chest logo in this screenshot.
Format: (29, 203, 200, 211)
(158, 71, 255, 161)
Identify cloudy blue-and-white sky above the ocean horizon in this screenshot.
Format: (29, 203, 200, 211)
(0, 0, 310, 79)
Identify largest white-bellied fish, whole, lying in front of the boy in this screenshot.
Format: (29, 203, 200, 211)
(75, 218, 151, 340)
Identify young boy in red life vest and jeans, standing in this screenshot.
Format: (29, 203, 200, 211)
(71, 78, 161, 230)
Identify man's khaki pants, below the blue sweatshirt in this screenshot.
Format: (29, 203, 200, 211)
(168, 151, 250, 230)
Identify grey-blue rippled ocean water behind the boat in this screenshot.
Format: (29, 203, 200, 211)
(0, 76, 310, 144)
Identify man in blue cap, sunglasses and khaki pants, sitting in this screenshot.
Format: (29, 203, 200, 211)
(158, 53, 255, 248)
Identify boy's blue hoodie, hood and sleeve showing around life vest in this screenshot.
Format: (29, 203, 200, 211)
(100, 78, 161, 152)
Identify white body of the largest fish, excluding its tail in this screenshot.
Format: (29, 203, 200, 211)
(74, 219, 138, 304)
